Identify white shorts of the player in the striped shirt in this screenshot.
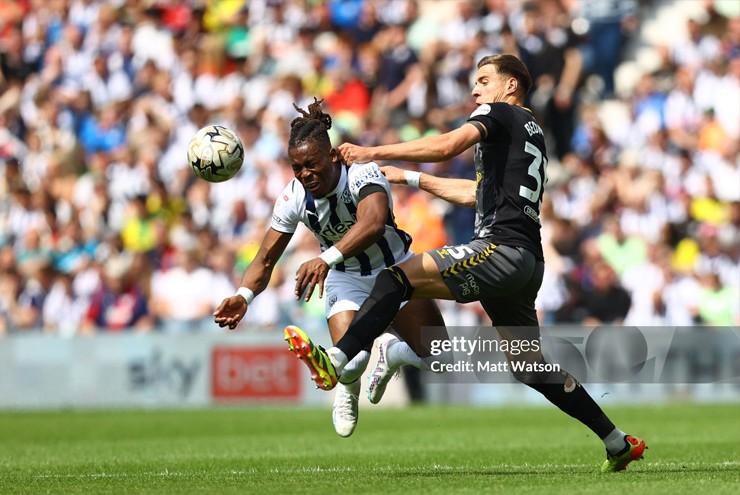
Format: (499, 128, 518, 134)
(324, 251, 414, 320)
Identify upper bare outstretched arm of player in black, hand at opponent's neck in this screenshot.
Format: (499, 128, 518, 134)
(337, 122, 481, 163)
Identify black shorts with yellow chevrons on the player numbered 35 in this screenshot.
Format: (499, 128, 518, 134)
(427, 239, 545, 326)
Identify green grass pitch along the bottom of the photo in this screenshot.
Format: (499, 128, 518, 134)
(0, 404, 740, 495)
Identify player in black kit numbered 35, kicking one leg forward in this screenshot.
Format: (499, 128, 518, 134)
(285, 55, 647, 472)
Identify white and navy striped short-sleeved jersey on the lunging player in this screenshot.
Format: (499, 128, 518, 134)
(270, 162, 411, 276)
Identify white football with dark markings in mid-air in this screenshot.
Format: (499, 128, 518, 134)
(188, 125, 244, 182)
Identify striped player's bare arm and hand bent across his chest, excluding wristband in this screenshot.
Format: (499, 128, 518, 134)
(295, 190, 388, 301)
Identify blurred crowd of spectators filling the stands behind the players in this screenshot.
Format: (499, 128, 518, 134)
(0, 0, 740, 336)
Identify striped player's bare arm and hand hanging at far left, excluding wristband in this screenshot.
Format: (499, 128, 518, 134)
(213, 229, 293, 330)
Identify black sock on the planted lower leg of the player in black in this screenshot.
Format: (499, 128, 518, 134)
(515, 363, 615, 440)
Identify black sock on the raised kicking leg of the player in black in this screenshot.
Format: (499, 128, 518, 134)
(336, 266, 414, 361)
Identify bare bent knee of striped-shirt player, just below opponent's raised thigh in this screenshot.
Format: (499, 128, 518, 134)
(392, 299, 449, 357)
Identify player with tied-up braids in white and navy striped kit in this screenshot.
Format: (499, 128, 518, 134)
(213, 100, 452, 437)
